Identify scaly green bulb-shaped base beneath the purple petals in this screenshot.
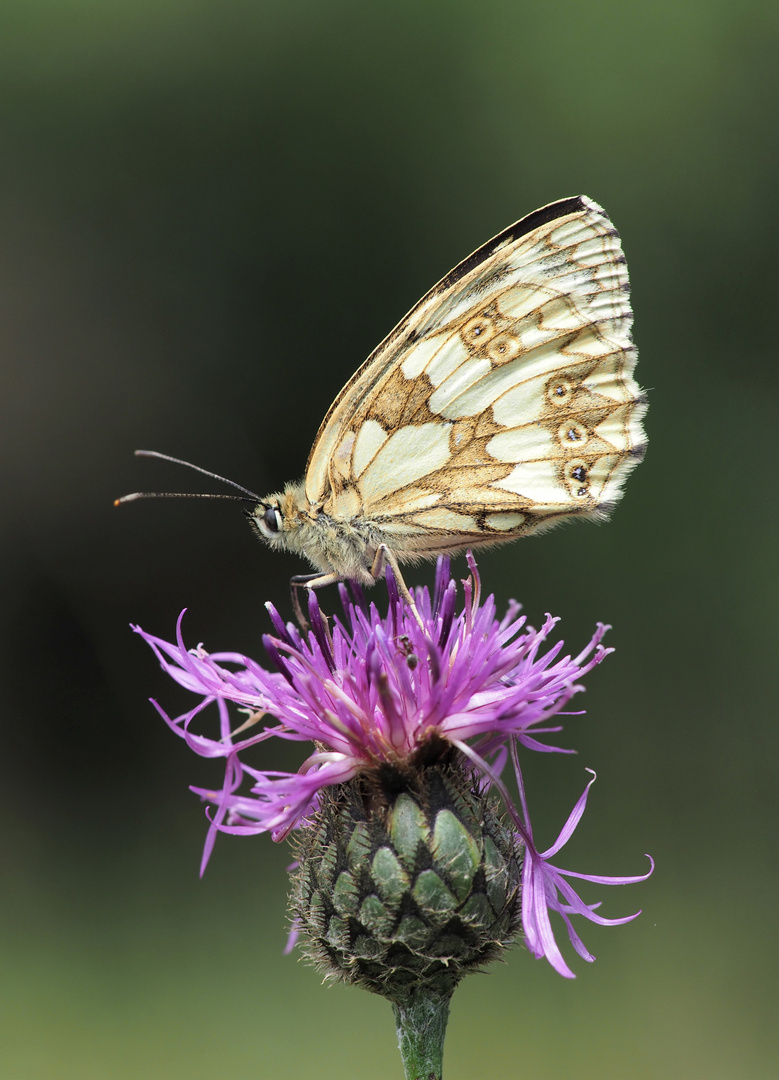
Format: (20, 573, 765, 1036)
(291, 759, 522, 1001)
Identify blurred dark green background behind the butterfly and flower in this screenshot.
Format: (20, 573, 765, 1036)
(0, 0, 779, 1080)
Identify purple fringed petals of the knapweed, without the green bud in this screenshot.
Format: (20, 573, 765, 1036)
(134, 555, 652, 977)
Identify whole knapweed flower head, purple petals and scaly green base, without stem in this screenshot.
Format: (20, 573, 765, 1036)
(136, 556, 652, 1000)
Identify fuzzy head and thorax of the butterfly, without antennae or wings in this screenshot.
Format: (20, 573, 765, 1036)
(250, 483, 384, 585)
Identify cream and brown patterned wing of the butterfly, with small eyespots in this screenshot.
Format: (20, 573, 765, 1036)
(305, 197, 646, 557)
